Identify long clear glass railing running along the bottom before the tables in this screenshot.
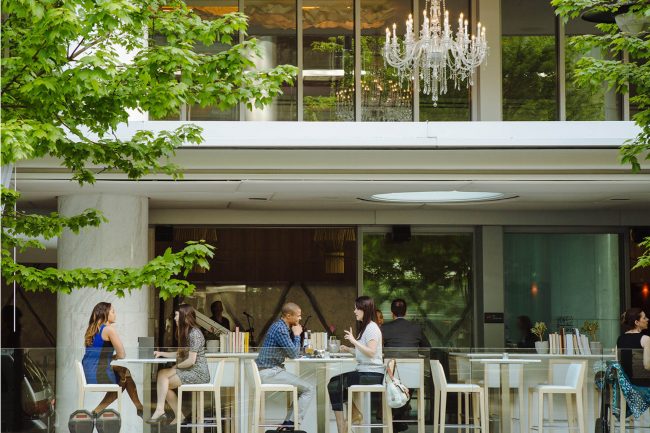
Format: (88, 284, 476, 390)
(1, 345, 624, 433)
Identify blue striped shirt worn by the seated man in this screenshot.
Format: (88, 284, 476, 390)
(255, 319, 300, 368)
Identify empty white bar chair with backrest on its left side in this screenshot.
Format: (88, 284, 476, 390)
(431, 359, 488, 433)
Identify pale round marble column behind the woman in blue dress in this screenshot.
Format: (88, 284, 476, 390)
(56, 194, 149, 433)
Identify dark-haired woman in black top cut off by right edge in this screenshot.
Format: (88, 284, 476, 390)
(616, 308, 650, 387)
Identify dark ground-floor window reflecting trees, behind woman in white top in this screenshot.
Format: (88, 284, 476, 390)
(363, 233, 474, 347)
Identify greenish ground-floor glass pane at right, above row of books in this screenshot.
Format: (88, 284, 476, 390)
(504, 233, 620, 347)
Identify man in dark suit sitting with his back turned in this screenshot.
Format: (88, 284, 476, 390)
(381, 298, 431, 432)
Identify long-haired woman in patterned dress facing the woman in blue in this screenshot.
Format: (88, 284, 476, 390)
(147, 304, 210, 425)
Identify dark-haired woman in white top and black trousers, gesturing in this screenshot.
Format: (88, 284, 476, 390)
(327, 296, 384, 433)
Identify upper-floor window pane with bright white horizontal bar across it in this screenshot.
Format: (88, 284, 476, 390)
(302, 0, 354, 121)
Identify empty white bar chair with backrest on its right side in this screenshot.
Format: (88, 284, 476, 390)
(528, 361, 587, 433)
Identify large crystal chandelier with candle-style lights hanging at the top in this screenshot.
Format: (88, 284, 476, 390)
(382, 0, 488, 107)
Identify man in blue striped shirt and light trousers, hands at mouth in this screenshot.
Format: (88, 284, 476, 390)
(255, 302, 316, 431)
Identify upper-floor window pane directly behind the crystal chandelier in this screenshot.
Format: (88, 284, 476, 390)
(420, 0, 468, 121)
